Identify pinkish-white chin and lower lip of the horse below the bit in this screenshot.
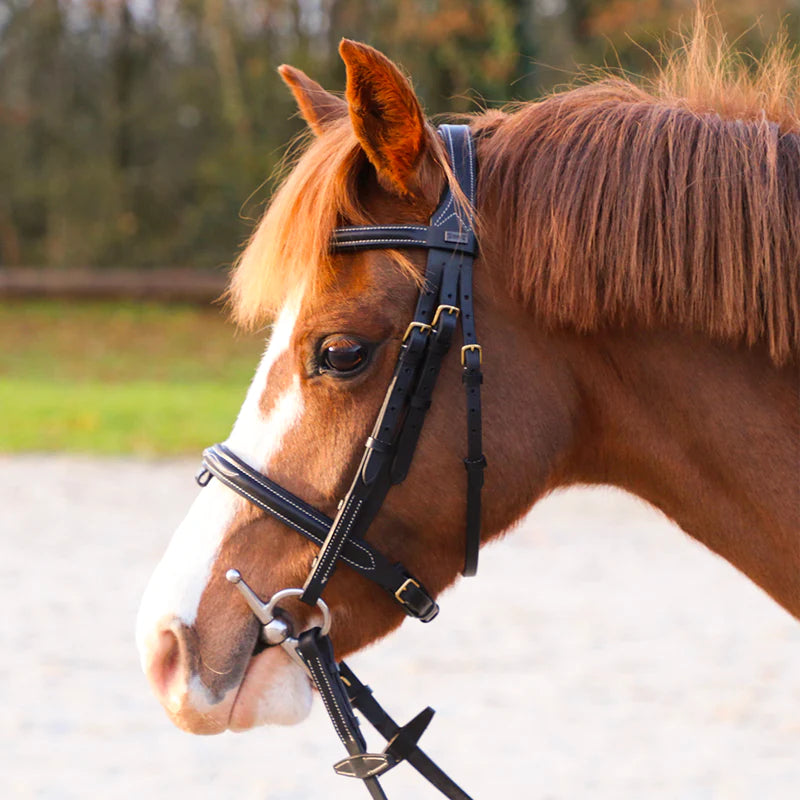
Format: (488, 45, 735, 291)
(227, 647, 312, 731)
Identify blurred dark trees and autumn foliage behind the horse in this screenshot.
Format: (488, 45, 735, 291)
(0, 0, 798, 267)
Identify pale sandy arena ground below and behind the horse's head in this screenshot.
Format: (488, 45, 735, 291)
(0, 457, 800, 800)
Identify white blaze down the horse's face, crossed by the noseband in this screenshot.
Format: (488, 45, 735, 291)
(136, 304, 303, 665)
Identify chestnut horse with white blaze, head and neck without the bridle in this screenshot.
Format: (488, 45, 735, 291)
(137, 36, 800, 752)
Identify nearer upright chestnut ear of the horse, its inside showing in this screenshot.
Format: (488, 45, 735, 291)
(339, 39, 425, 195)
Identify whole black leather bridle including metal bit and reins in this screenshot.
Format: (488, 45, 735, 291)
(197, 125, 486, 800)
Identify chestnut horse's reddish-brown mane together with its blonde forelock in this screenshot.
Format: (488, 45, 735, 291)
(229, 16, 800, 364)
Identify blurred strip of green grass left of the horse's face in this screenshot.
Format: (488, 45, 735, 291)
(0, 303, 264, 455)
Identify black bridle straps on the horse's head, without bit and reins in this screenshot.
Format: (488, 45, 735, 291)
(204, 125, 486, 608)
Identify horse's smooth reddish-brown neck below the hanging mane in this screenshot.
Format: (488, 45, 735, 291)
(562, 333, 800, 617)
